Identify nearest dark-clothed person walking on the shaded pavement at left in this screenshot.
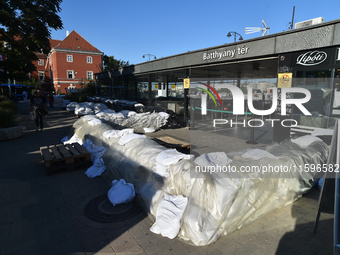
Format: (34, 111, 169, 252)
(28, 89, 48, 131)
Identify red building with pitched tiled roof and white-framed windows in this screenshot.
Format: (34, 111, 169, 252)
(31, 31, 103, 93)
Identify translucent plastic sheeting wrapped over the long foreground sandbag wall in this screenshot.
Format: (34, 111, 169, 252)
(69, 119, 328, 246)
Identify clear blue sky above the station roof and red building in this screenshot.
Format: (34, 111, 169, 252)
(51, 0, 340, 64)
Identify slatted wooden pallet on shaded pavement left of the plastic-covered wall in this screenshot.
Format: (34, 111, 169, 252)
(40, 143, 91, 174)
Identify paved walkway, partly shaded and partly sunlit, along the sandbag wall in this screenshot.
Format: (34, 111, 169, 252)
(0, 98, 333, 255)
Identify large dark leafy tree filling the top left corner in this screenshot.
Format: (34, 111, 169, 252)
(0, 0, 63, 81)
